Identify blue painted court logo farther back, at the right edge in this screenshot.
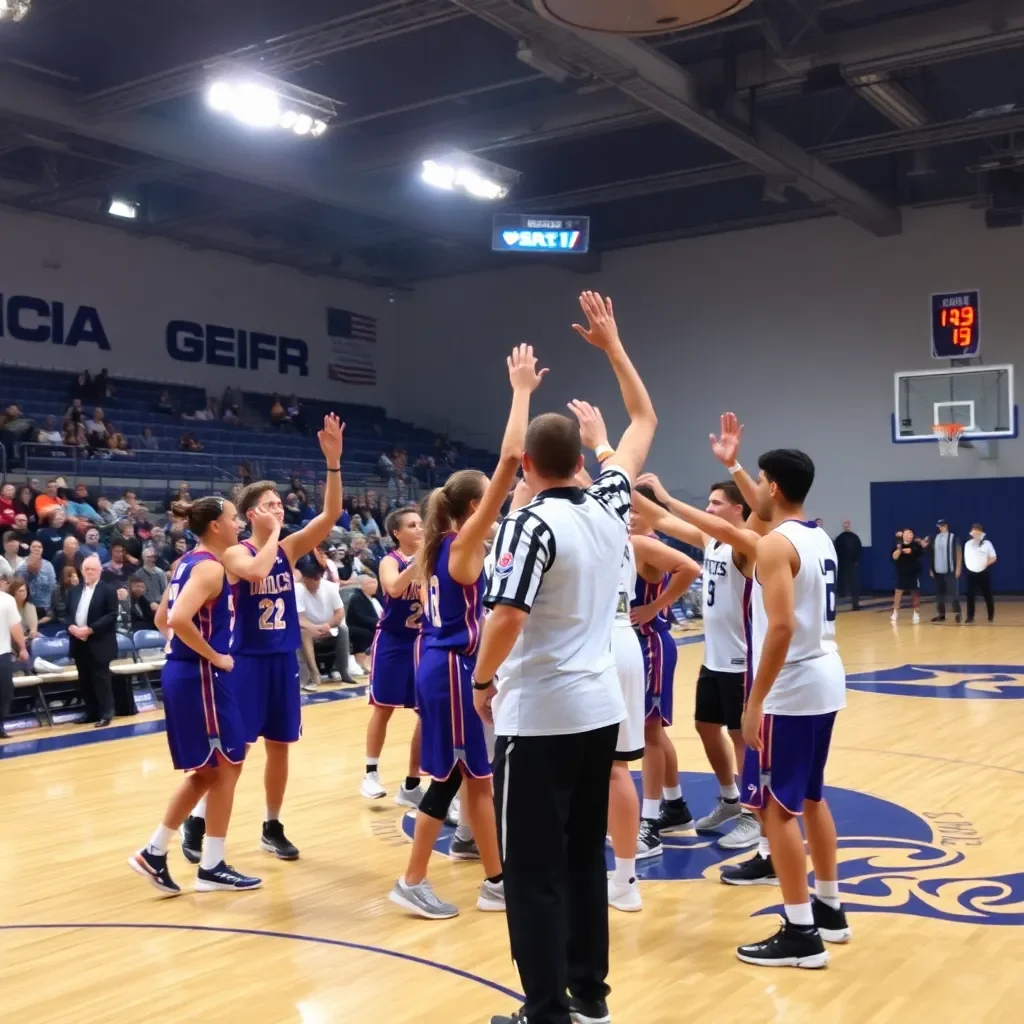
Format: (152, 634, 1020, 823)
(846, 665, 1024, 700)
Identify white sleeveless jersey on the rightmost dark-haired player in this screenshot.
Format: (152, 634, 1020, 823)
(751, 519, 846, 715)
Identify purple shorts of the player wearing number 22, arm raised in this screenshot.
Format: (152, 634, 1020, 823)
(231, 651, 302, 743)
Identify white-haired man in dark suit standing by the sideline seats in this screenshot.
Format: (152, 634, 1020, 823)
(65, 555, 118, 729)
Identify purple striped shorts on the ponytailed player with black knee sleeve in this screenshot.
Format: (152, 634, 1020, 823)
(416, 647, 490, 781)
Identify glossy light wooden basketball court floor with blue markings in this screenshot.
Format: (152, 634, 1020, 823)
(0, 603, 1024, 1024)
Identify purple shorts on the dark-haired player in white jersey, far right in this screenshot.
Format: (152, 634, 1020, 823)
(740, 712, 836, 814)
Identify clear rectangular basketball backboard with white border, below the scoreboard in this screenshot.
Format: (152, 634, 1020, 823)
(892, 365, 1018, 444)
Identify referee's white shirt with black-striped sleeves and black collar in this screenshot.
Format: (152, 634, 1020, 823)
(484, 466, 631, 736)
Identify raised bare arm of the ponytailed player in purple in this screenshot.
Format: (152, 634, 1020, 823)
(449, 345, 548, 586)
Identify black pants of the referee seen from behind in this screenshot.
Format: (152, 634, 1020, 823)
(495, 725, 618, 1024)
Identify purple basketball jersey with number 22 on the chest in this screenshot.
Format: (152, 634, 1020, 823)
(231, 541, 302, 656)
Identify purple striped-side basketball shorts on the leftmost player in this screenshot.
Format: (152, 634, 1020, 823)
(161, 659, 246, 771)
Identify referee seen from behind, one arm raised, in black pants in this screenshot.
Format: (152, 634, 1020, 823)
(473, 292, 656, 1024)
